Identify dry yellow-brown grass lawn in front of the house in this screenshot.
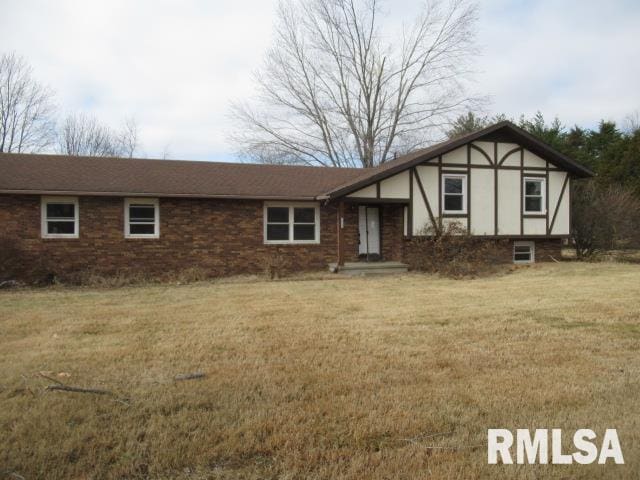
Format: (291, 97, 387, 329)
(0, 263, 640, 479)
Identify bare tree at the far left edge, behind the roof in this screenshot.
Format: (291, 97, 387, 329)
(0, 53, 55, 153)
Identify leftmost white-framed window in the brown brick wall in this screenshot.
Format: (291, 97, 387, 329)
(40, 197, 80, 238)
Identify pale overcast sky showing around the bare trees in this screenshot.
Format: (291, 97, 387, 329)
(0, 0, 640, 160)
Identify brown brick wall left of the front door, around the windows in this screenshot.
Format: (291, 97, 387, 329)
(0, 195, 357, 281)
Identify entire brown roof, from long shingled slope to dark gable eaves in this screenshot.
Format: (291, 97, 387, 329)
(0, 122, 593, 200)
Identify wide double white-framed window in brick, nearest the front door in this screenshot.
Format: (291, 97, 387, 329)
(264, 202, 320, 244)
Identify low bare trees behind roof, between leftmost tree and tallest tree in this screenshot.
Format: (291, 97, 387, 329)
(58, 113, 138, 158)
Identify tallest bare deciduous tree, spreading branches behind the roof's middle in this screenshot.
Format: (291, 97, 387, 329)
(231, 0, 476, 167)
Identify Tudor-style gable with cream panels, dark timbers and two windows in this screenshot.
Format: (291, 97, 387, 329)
(328, 122, 591, 238)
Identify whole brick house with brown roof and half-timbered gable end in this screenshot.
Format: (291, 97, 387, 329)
(0, 122, 592, 281)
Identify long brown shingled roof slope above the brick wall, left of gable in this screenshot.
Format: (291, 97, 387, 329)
(0, 153, 362, 200)
